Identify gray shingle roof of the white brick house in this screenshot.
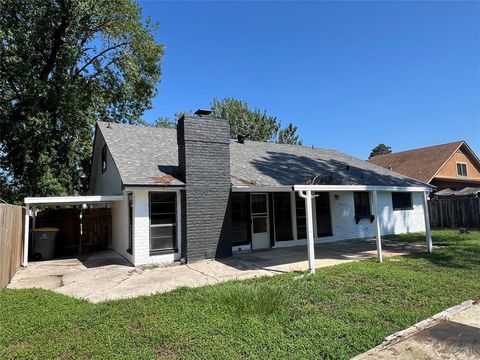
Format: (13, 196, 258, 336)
(98, 123, 425, 186)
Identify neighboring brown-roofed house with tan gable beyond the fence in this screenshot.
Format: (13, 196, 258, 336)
(368, 141, 480, 190)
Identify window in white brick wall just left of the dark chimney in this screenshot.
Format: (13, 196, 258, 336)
(150, 192, 178, 254)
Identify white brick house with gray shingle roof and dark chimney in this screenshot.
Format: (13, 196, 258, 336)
(90, 112, 431, 265)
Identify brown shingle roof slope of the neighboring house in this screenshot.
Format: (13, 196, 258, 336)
(368, 141, 464, 183)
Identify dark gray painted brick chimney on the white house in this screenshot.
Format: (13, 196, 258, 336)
(177, 110, 232, 262)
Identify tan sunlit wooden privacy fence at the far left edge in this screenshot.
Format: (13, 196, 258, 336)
(0, 204, 24, 291)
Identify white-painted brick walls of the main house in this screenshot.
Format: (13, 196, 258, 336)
(128, 189, 425, 266)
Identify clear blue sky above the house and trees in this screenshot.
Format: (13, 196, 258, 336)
(140, 1, 480, 159)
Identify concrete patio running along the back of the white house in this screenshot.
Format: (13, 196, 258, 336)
(8, 240, 426, 302)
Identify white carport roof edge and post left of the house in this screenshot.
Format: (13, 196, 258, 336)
(22, 195, 123, 266)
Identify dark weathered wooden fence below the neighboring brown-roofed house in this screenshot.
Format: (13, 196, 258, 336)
(428, 197, 480, 228)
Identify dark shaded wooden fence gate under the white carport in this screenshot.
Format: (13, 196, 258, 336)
(35, 208, 112, 256)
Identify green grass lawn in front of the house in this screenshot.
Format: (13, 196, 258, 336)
(0, 231, 480, 359)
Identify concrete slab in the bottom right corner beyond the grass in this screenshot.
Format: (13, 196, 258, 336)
(352, 300, 480, 360)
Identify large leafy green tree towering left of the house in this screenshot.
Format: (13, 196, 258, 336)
(0, 0, 163, 201)
